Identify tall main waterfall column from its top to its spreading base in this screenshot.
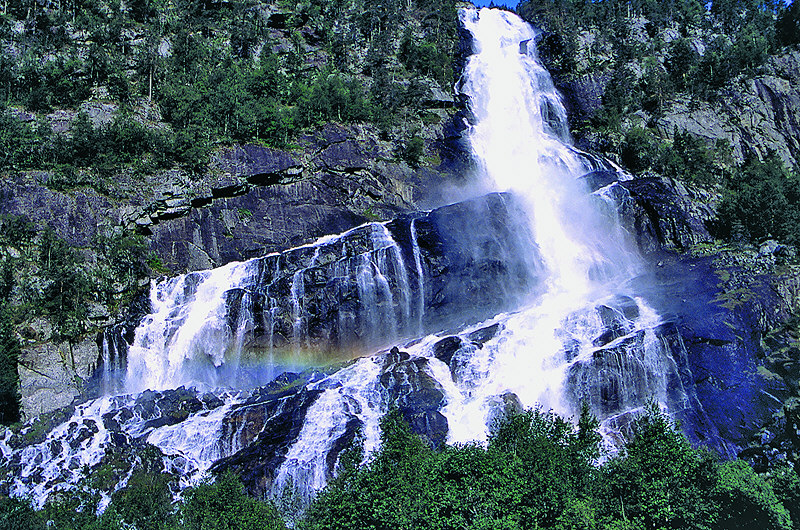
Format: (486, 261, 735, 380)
(419, 9, 680, 443)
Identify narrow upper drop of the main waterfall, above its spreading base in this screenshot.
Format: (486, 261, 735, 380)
(459, 8, 638, 293)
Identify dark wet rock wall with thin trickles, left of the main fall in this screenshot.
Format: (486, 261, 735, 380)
(209, 190, 539, 351)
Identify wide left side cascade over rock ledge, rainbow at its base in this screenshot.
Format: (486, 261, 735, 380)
(122, 221, 424, 392)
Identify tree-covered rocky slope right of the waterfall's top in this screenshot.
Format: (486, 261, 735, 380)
(517, 0, 800, 244)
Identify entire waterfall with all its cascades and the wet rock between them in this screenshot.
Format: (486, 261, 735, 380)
(0, 9, 728, 508)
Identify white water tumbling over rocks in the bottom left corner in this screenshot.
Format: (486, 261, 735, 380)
(0, 394, 241, 507)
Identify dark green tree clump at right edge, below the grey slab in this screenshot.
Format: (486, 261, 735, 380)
(719, 154, 800, 245)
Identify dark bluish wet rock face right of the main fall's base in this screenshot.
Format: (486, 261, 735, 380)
(638, 251, 797, 456)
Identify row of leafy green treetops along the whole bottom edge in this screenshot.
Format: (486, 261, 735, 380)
(7, 405, 800, 530)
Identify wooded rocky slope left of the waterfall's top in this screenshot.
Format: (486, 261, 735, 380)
(0, 0, 457, 177)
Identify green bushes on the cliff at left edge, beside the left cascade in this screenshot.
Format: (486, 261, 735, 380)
(0, 210, 158, 424)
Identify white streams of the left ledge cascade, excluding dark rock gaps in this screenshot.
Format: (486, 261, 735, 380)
(121, 219, 424, 393)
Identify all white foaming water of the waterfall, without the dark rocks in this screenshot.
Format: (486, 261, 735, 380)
(0, 5, 688, 508)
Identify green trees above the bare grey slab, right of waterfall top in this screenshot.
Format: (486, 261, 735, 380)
(517, 0, 788, 186)
